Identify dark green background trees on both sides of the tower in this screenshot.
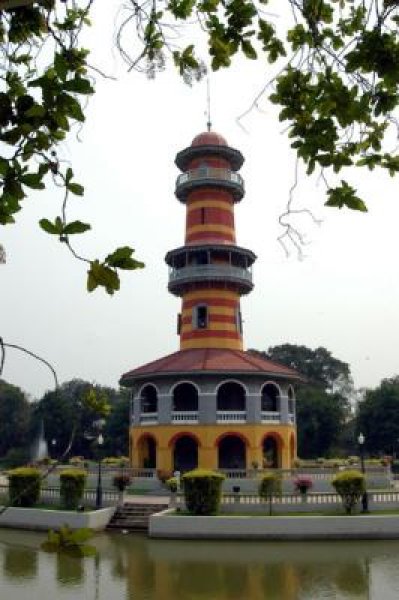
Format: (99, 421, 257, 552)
(0, 344, 399, 464)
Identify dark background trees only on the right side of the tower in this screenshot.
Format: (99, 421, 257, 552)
(251, 344, 399, 459)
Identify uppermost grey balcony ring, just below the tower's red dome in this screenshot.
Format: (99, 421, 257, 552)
(175, 167, 245, 202)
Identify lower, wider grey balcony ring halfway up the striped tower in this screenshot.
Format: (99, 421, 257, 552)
(168, 264, 253, 296)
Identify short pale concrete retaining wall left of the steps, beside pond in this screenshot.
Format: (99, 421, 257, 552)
(0, 507, 115, 531)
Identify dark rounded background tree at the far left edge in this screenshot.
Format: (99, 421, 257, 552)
(0, 379, 31, 456)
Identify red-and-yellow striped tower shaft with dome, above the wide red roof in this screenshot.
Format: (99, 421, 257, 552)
(165, 132, 256, 350)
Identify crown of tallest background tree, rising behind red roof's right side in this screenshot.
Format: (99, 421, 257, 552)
(251, 344, 352, 392)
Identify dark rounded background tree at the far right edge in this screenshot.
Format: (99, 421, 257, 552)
(357, 375, 399, 455)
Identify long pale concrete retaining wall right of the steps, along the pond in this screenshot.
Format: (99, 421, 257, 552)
(149, 509, 399, 540)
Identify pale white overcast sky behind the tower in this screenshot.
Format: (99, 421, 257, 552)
(0, 0, 399, 397)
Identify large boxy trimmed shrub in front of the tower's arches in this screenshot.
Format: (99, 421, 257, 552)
(181, 469, 225, 515)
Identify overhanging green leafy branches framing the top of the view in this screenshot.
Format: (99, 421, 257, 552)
(0, 0, 399, 294)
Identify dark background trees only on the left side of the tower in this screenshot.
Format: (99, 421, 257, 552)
(0, 379, 129, 466)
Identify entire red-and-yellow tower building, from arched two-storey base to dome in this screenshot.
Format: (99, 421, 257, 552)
(120, 131, 301, 471)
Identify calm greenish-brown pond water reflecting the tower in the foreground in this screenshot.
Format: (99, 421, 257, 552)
(0, 530, 399, 600)
